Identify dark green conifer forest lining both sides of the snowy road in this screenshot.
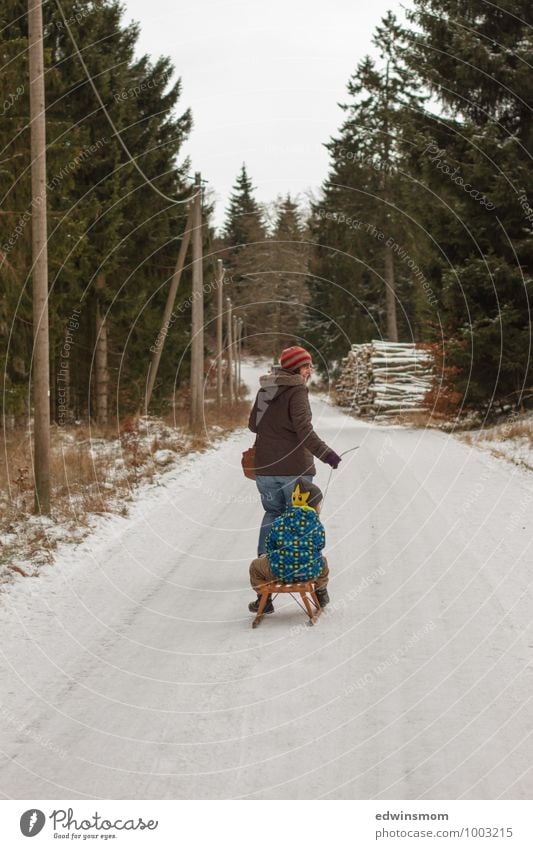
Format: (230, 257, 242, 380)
(0, 0, 533, 421)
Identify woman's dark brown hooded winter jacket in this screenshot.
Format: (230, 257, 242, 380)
(248, 369, 331, 475)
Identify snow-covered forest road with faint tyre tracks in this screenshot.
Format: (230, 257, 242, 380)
(0, 368, 533, 799)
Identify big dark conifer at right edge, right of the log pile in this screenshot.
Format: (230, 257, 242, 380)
(408, 0, 533, 409)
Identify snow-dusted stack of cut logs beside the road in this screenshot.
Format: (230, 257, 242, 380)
(336, 340, 433, 418)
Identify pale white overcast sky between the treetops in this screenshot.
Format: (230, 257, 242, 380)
(120, 0, 403, 229)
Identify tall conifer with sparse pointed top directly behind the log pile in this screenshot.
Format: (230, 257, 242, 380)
(309, 13, 423, 358)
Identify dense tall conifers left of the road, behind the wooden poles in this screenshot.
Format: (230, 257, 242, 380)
(0, 0, 196, 423)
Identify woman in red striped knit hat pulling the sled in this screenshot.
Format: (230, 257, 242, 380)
(248, 346, 341, 557)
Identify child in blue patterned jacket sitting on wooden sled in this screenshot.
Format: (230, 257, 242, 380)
(248, 478, 329, 613)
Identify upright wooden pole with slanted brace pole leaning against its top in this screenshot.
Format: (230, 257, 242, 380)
(190, 176, 204, 431)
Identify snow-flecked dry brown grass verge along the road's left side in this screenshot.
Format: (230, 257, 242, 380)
(0, 401, 250, 580)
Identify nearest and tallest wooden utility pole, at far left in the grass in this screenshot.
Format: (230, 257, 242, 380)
(28, 0, 50, 515)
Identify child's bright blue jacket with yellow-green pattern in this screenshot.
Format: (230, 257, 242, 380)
(266, 507, 326, 583)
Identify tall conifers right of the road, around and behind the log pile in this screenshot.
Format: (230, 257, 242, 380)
(307, 0, 533, 408)
